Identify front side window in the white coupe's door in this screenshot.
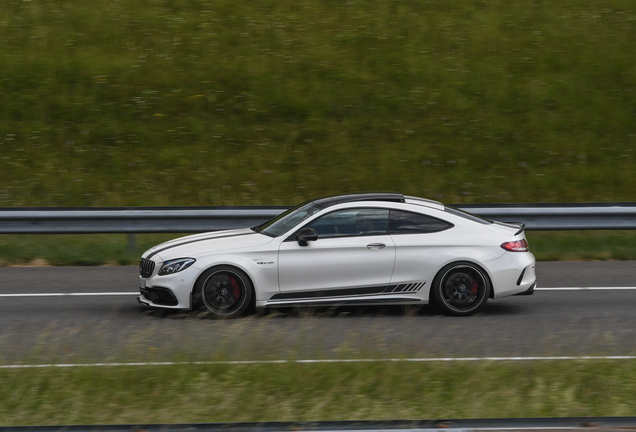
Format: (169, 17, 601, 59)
(307, 208, 389, 239)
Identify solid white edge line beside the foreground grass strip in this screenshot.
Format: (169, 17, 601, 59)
(0, 356, 636, 369)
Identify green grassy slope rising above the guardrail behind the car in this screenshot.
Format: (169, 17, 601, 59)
(0, 0, 636, 207)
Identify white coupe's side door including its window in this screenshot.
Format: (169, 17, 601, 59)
(278, 208, 395, 298)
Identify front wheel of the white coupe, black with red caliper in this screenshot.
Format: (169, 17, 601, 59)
(195, 266, 254, 318)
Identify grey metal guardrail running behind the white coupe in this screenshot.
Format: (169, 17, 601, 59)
(0, 203, 636, 234)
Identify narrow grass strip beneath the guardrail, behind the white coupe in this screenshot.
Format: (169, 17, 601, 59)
(0, 231, 636, 266)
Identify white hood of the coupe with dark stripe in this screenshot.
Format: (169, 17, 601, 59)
(142, 228, 272, 261)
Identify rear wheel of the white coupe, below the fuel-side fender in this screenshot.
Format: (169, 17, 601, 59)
(433, 262, 491, 316)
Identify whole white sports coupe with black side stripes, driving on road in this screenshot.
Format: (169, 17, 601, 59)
(138, 193, 536, 317)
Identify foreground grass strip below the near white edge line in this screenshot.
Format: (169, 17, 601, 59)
(0, 360, 636, 426)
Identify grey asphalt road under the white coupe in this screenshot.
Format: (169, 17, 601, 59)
(0, 261, 636, 364)
